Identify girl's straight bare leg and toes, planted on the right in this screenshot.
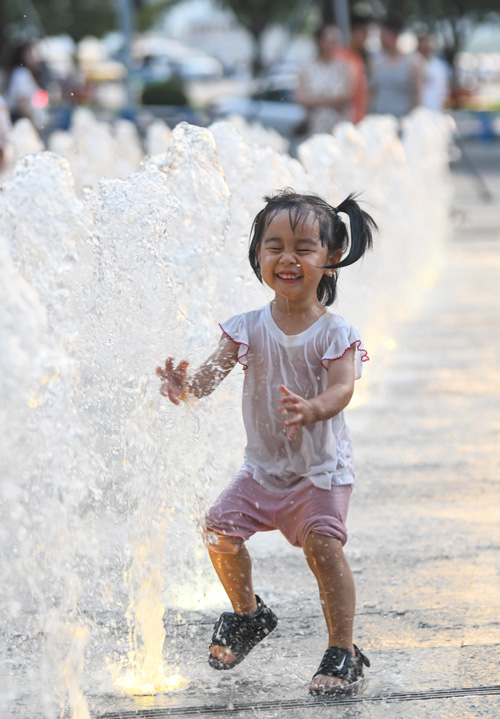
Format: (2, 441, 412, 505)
(304, 532, 356, 689)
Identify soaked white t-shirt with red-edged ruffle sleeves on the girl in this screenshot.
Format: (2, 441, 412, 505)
(220, 305, 368, 491)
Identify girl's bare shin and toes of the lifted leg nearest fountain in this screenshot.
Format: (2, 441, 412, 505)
(209, 545, 257, 664)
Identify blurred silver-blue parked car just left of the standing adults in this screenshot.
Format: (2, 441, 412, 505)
(211, 76, 306, 137)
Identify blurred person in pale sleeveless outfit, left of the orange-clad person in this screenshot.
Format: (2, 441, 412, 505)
(295, 25, 355, 135)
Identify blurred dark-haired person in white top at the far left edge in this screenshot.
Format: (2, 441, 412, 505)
(6, 42, 45, 127)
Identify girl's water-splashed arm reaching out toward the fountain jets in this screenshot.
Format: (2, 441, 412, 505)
(156, 334, 238, 404)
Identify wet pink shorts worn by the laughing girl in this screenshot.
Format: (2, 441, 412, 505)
(203, 471, 352, 554)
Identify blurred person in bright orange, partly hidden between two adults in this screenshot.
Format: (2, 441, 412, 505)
(337, 13, 371, 123)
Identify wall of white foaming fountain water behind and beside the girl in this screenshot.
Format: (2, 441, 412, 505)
(0, 111, 450, 719)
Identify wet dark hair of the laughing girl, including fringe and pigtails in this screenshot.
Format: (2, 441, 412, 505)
(248, 188, 377, 306)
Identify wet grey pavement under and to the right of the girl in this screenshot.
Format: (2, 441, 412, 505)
(93, 138, 500, 719)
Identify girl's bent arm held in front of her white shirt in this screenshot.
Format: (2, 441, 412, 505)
(278, 345, 356, 440)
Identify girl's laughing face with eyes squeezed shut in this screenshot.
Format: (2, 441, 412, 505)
(257, 210, 342, 305)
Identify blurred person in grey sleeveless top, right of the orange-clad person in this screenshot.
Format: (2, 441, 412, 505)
(370, 15, 422, 117)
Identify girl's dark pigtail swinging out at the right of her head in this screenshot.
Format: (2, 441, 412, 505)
(328, 194, 378, 269)
